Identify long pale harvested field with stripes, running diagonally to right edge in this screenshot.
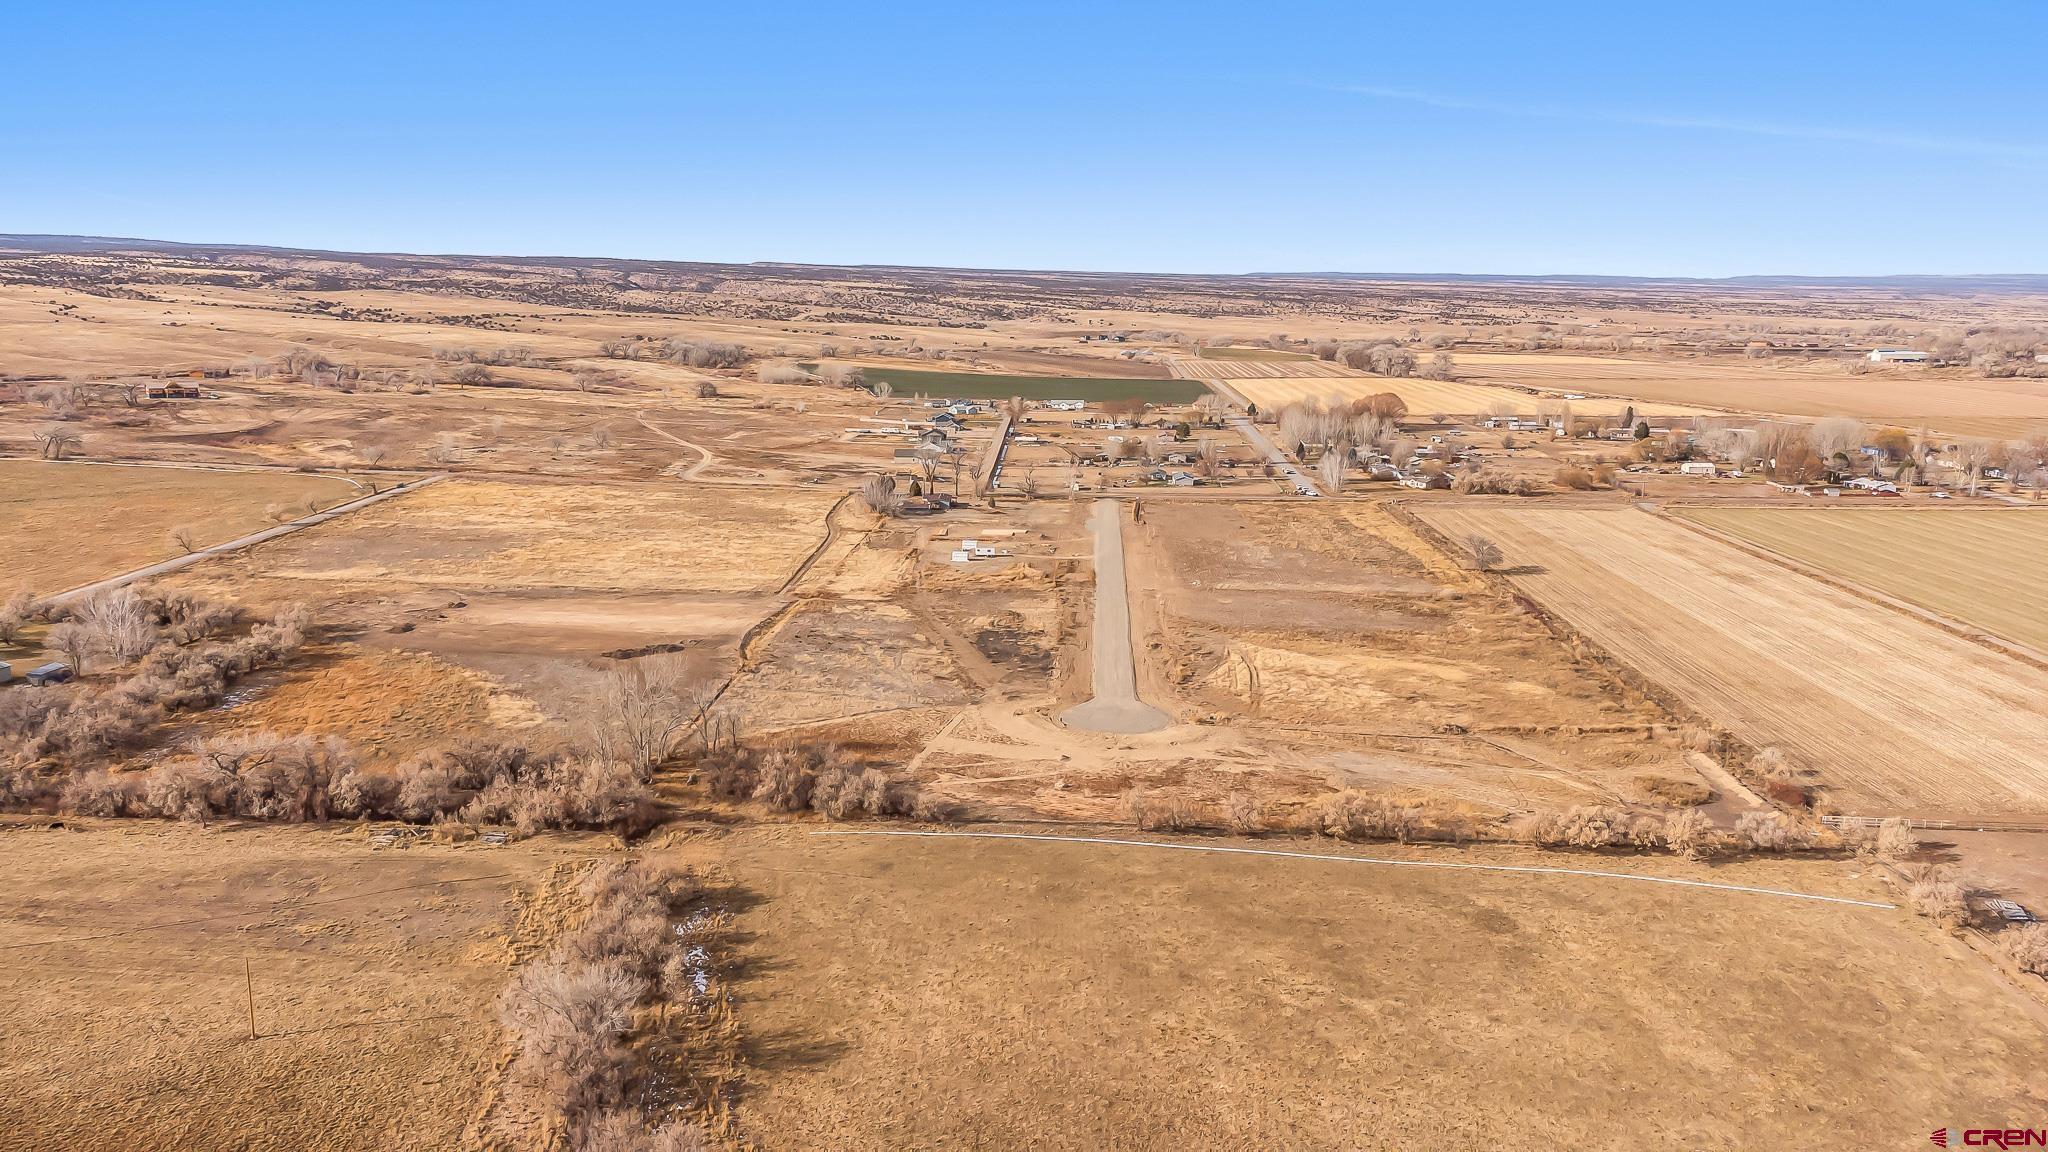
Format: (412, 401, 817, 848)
(1427, 508, 2048, 818)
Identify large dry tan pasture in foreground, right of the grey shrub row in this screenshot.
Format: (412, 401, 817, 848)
(712, 830, 2048, 1150)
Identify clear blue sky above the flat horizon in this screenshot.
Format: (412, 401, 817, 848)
(0, 0, 2048, 277)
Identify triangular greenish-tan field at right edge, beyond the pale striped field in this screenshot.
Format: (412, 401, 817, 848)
(1677, 508, 2048, 652)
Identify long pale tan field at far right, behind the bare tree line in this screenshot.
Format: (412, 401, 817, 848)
(1452, 353, 2048, 437)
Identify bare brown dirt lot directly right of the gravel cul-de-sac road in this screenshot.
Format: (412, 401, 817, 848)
(1141, 504, 1694, 812)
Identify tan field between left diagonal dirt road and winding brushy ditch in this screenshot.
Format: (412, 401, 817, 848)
(164, 478, 842, 705)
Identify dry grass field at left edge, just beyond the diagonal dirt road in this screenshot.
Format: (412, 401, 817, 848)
(0, 459, 358, 592)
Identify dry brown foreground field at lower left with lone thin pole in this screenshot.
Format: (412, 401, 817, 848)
(0, 822, 598, 1152)
